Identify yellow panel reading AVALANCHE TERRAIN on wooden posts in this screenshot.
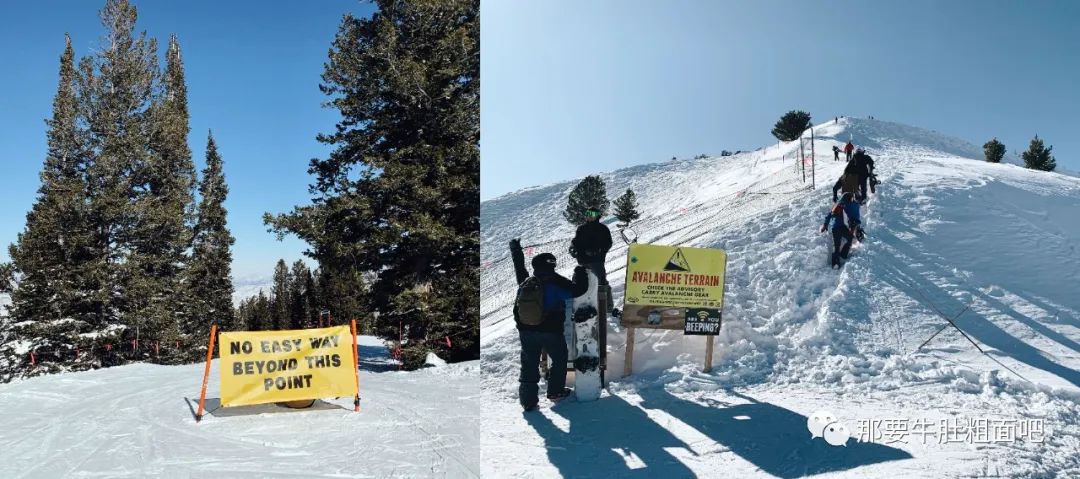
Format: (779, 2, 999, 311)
(625, 243, 728, 310)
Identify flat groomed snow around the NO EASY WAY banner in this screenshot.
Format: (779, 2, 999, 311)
(0, 337, 481, 478)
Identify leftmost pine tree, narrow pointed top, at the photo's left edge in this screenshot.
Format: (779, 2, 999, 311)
(0, 32, 94, 381)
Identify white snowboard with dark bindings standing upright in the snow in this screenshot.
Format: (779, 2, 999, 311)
(570, 271, 606, 401)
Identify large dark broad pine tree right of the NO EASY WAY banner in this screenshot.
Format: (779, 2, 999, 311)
(267, 0, 480, 367)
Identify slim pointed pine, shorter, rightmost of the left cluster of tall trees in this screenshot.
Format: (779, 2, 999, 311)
(184, 133, 234, 349)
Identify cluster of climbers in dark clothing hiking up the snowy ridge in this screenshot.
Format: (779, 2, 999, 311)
(821, 141, 877, 268)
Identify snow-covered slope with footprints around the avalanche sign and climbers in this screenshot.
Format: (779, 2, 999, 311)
(481, 119, 1080, 478)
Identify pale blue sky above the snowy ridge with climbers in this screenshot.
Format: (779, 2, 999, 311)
(481, 0, 1080, 200)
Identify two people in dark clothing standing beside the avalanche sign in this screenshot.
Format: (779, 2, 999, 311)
(510, 203, 611, 411)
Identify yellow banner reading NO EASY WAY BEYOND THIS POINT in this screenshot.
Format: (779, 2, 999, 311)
(219, 326, 356, 407)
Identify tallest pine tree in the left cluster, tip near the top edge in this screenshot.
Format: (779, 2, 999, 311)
(80, 0, 162, 366)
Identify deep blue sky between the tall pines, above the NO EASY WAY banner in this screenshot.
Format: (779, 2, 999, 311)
(0, 0, 374, 278)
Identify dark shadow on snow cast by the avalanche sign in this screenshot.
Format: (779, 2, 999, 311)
(638, 387, 912, 478)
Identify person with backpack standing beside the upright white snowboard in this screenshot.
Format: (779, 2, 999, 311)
(510, 240, 589, 411)
